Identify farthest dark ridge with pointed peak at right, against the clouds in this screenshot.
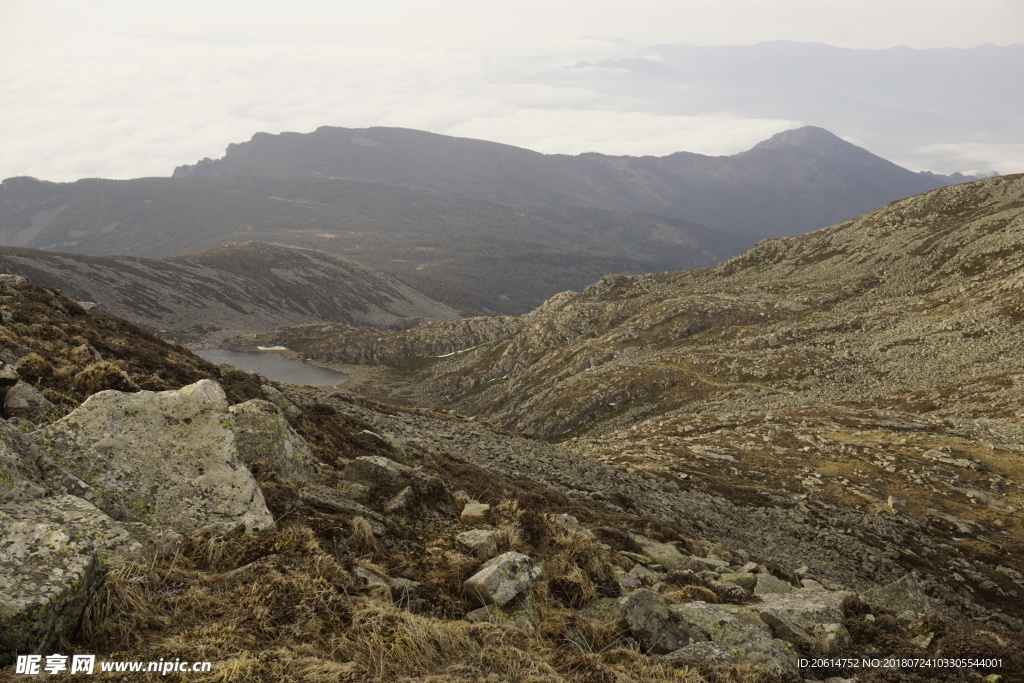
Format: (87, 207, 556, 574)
(174, 127, 965, 237)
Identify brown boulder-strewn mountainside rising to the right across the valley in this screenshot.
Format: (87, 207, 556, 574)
(245, 175, 1024, 628)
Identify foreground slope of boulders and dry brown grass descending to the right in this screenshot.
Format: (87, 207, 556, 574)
(0, 270, 1024, 683)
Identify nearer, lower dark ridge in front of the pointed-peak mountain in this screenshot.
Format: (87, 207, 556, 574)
(0, 177, 729, 313)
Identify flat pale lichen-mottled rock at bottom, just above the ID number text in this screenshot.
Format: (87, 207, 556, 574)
(672, 602, 798, 673)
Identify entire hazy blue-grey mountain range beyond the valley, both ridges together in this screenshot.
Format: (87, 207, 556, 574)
(0, 127, 963, 314)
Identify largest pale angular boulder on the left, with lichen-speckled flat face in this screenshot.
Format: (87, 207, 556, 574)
(32, 380, 274, 533)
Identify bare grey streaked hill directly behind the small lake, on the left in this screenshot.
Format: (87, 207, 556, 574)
(0, 243, 460, 345)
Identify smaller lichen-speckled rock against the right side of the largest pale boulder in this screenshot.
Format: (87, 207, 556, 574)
(228, 398, 321, 481)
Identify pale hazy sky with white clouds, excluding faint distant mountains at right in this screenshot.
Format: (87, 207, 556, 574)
(0, 0, 1024, 180)
